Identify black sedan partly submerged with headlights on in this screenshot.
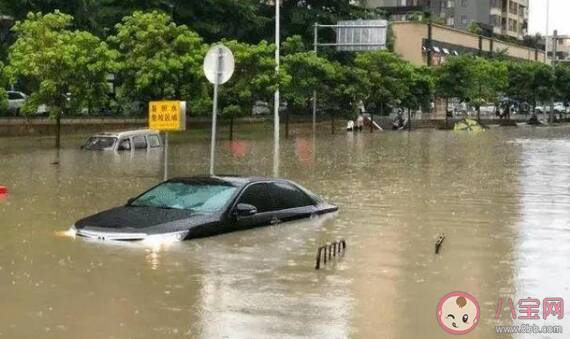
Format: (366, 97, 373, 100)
(72, 176, 338, 240)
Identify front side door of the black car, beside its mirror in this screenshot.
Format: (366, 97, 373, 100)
(233, 182, 274, 230)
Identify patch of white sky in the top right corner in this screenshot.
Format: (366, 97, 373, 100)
(528, 0, 570, 35)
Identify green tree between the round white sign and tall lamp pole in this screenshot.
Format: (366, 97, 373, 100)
(220, 40, 278, 140)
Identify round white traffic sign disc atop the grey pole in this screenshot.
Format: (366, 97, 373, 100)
(204, 45, 235, 85)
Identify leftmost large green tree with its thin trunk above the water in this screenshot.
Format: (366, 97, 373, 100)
(7, 11, 114, 147)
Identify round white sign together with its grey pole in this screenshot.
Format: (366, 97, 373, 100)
(204, 44, 235, 175)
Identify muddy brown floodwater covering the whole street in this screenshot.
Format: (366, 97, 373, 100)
(0, 127, 570, 339)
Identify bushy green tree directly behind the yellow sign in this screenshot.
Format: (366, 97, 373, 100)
(109, 11, 206, 113)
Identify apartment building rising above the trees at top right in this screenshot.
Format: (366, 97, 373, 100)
(360, 0, 529, 39)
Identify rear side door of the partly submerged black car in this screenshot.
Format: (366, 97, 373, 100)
(268, 181, 317, 222)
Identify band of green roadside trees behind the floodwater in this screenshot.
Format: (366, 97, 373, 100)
(0, 0, 570, 132)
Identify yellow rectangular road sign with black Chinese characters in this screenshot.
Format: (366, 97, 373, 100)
(148, 101, 186, 132)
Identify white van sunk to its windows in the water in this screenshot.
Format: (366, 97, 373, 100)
(81, 129, 162, 151)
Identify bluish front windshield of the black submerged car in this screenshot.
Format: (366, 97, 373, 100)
(130, 182, 236, 213)
